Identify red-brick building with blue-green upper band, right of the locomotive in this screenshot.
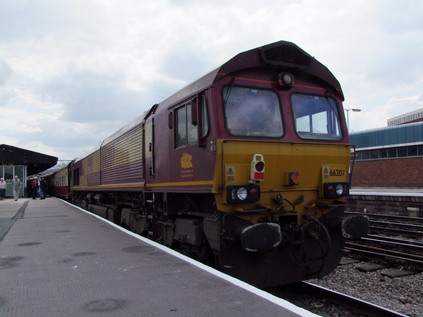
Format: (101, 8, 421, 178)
(350, 118, 423, 188)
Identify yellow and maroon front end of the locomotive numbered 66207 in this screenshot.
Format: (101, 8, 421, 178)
(196, 40, 368, 285)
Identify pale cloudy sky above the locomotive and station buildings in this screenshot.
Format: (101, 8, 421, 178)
(0, 0, 423, 160)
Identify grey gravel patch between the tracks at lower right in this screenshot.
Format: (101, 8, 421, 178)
(309, 262, 423, 317)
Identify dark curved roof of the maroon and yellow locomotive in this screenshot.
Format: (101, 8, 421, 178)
(76, 41, 344, 158)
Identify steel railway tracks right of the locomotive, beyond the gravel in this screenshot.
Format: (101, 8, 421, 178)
(345, 213, 423, 271)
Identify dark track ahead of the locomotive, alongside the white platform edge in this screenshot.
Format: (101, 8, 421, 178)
(271, 282, 407, 317)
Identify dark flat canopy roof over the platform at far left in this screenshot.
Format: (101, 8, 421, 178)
(0, 144, 58, 175)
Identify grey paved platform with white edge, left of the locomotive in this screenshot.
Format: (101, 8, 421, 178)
(0, 198, 316, 317)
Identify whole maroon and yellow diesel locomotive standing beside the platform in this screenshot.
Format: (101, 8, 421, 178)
(49, 41, 368, 287)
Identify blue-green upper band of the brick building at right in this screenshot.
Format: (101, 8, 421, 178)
(350, 122, 423, 149)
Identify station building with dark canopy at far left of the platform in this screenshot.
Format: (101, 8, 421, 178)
(0, 144, 58, 197)
